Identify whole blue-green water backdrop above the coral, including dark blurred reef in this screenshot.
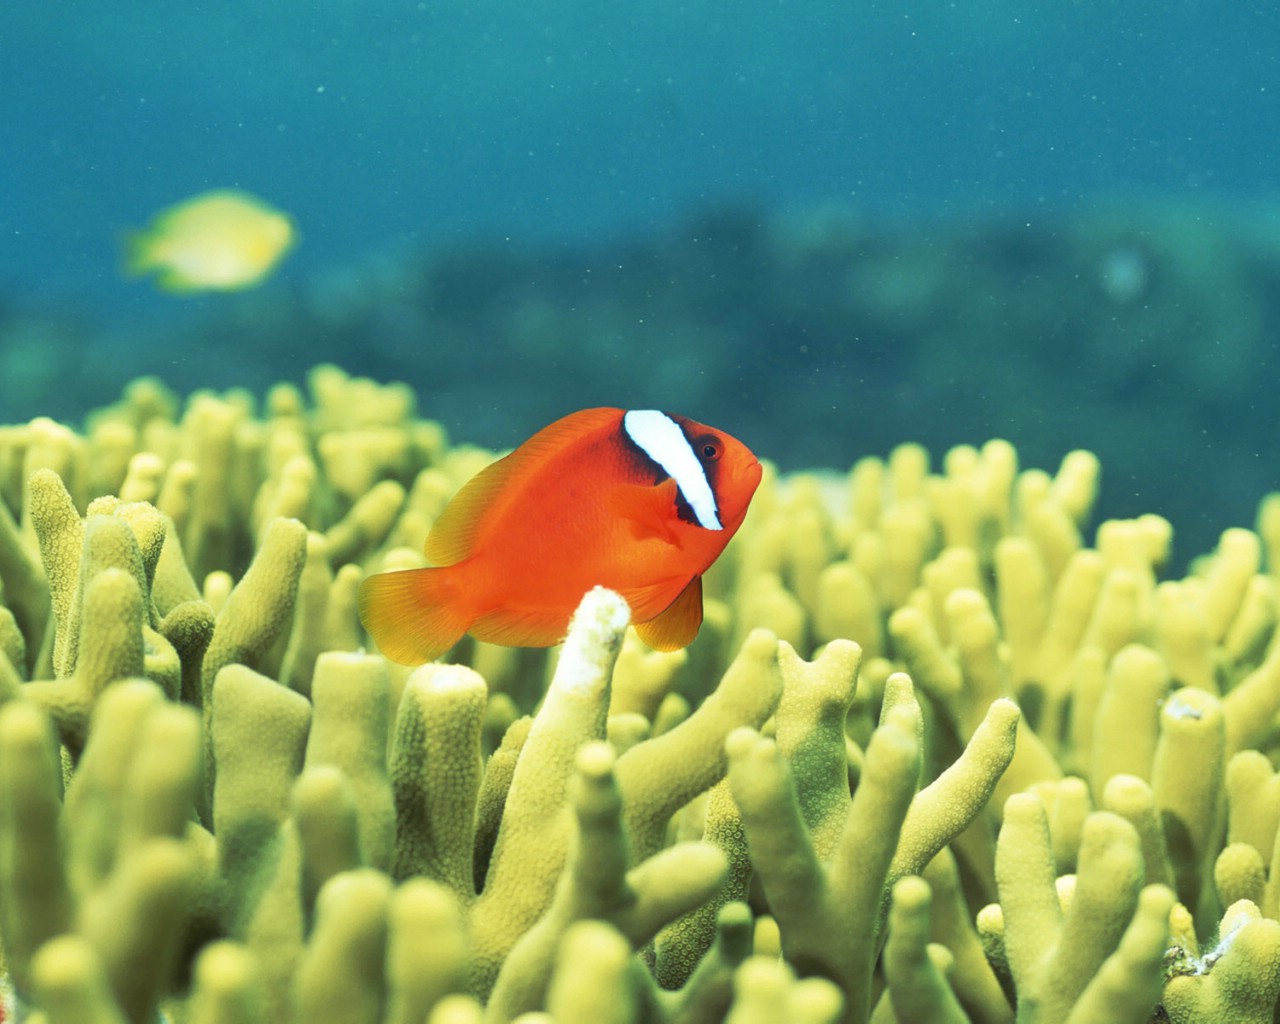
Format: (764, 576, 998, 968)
(0, 0, 1280, 554)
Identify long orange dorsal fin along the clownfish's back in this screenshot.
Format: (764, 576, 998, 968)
(426, 408, 622, 566)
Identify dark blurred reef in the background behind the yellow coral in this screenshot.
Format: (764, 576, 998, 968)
(0, 202, 1280, 563)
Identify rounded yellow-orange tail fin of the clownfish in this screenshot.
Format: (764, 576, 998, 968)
(360, 568, 471, 664)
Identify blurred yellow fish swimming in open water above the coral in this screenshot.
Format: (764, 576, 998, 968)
(124, 188, 294, 292)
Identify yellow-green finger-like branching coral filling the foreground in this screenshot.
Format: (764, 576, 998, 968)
(0, 367, 1280, 1024)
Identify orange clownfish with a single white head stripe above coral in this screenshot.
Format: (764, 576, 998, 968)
(360, 408, 760, 664)
